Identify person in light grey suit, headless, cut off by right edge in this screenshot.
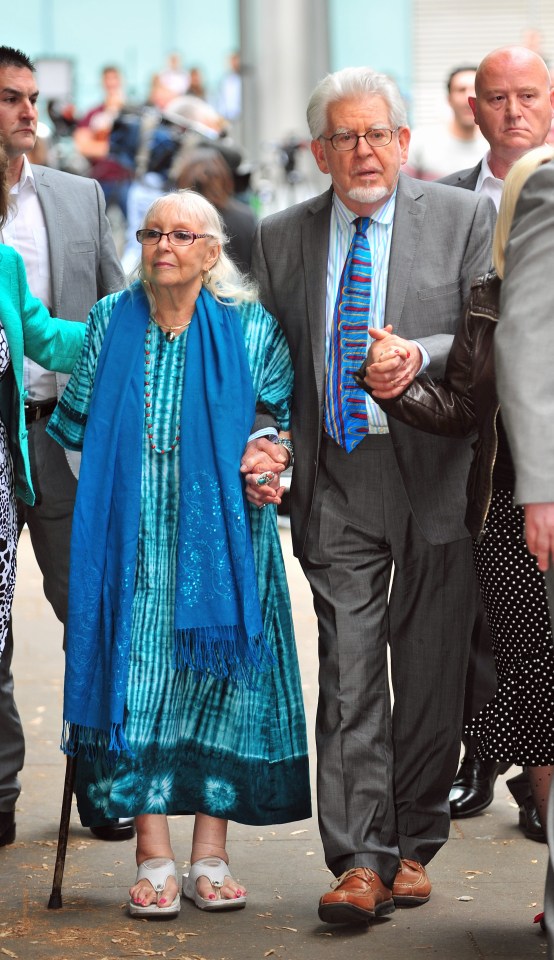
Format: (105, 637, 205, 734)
(494, 162, 554, 960)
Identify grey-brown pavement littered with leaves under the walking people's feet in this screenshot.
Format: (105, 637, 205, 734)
(0, 529, 547, 960)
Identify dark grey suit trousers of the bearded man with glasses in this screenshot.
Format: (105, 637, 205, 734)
(302, 435, 478, 885)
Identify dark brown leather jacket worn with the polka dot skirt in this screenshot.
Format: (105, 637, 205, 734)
(368, 273, 500, 539)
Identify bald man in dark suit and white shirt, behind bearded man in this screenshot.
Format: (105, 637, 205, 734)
(441, 47, 553, 828)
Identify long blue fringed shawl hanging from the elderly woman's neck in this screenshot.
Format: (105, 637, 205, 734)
(62, 282, 274, 755)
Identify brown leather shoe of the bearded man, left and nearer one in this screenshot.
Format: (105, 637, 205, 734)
(318, 867, 394, 923)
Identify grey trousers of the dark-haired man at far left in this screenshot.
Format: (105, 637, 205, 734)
(0, 417, 77, 812)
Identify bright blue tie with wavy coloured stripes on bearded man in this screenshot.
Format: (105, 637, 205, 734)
(325, 217, 373, 453)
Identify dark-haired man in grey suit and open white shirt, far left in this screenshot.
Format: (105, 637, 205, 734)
(0, 47, 126, 846)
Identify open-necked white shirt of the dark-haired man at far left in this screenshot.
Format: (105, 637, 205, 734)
(2, 154, 56, 401)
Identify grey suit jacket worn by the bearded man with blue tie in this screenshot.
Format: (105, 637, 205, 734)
(253, 175, 495, 556)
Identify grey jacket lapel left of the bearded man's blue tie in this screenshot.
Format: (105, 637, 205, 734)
(301, 188, 333, 405)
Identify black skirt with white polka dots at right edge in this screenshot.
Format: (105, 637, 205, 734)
(466, 490, 554, 766)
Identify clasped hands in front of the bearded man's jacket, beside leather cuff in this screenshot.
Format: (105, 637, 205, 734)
(364, 323, 422, 400)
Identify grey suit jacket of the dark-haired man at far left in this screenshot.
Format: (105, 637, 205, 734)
(33, 165, 125, 473)
